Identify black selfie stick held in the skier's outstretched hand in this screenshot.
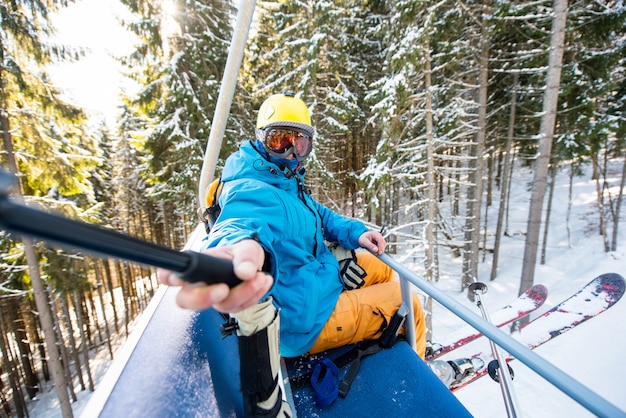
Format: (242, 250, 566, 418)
(0, 171, 241, 287)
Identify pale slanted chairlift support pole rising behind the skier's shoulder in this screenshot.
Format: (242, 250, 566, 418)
(198, 0, 256, 208)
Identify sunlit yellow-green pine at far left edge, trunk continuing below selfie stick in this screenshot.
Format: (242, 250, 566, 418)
(0, 1, 98, 417)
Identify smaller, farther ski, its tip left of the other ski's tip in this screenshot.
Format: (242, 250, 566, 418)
(425, 284, 548, 361)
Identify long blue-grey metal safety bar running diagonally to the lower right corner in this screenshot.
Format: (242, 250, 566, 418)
(378, 254, 626, 418)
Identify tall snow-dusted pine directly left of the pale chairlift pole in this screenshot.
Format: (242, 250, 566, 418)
(119, 0, 232, 236)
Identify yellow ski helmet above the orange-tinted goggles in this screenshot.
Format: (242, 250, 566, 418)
(256, 92, 315, 138)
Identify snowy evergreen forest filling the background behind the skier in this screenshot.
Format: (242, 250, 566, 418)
(0, 0, 626, 417)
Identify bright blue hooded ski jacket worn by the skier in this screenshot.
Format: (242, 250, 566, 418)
(207, 141, 367, 357)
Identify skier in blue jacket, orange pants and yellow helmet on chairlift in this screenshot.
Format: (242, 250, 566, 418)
(159, 93, 426, 414)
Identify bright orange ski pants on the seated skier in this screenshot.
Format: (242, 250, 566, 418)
(309, 252, 426, 358)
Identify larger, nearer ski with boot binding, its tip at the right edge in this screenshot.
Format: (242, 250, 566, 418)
(438, 273, 626, 391)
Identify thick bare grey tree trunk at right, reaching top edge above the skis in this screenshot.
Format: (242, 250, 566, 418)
(519, 0, 567, 295)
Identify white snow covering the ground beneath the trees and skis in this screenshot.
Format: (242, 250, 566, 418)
(30, 162, 626, 418)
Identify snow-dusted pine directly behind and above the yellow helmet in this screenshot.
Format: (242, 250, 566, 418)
(246, 1, 388, 212)
